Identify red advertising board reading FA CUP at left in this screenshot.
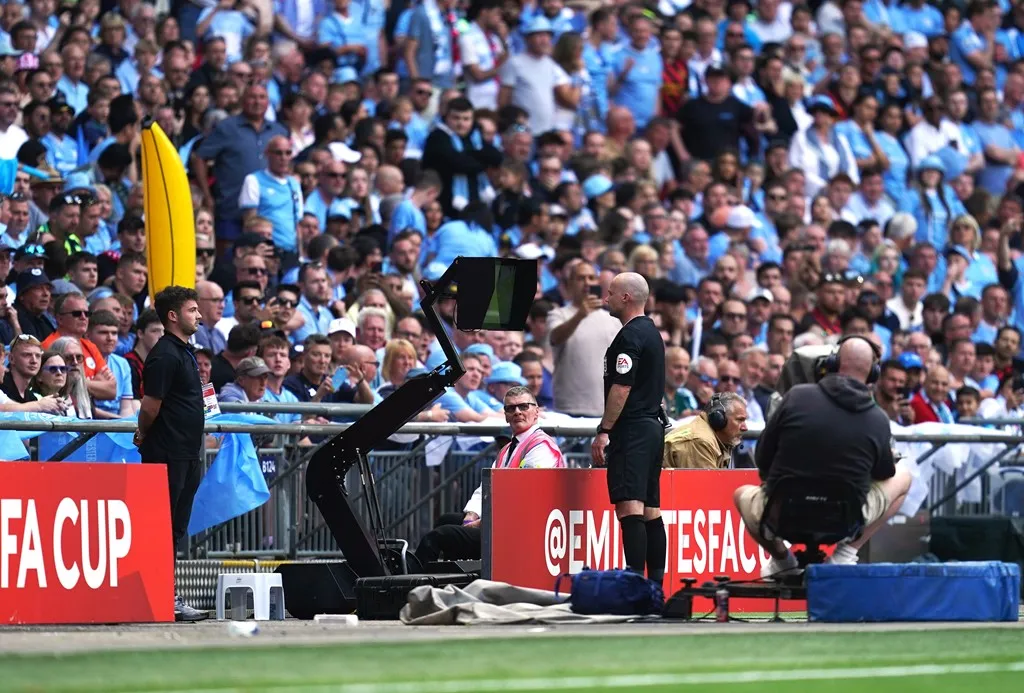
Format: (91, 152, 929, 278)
(0, 462, 174, 623)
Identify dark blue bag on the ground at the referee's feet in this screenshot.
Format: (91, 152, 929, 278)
(555, 568, 665, 616)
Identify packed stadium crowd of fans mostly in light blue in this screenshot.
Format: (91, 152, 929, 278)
(0, 0, 1024, 444)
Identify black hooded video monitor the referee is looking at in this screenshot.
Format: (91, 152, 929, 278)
(455, 258, 537, 331)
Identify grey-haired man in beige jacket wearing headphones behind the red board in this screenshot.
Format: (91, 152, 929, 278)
(662, 392, 746, 469)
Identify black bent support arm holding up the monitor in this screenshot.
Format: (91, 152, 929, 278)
(306, 259, 466, 577)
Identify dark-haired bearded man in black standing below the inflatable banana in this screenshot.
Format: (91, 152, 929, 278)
(135, 287, 209, 621)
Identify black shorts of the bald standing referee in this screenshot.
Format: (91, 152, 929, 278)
(604, 419, 665, 508)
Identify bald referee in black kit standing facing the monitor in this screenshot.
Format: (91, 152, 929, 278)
(591, 272, 666, 584)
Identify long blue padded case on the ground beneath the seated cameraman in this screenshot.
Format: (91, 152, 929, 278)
(806, 561, 1021, 623)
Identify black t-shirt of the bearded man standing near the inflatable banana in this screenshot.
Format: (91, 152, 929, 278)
(139, 334, 205, 462)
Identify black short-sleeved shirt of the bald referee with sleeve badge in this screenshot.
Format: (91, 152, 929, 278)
(604, 315, 665, 427)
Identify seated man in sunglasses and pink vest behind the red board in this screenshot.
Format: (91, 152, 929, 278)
(416, 385, 565, 564)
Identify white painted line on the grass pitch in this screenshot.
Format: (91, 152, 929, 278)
(150, 661, 1024, 693)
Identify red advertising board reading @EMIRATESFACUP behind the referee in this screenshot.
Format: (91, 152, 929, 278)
(484, 469, 803, 611)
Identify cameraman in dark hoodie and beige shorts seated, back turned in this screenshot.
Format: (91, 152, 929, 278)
(733, 337, 910, 577)
